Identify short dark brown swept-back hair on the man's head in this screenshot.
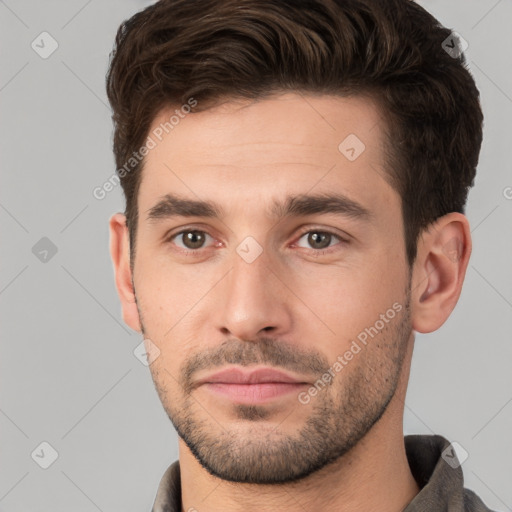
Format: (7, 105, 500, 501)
(106, 0, 483, 266)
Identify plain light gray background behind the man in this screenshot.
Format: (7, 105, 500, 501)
(0, 0, 512, 512)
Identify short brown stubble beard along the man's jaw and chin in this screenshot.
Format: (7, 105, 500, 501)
(143, 288, 411, 485)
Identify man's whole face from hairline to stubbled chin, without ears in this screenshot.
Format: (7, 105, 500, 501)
(133, 93, 411, 484)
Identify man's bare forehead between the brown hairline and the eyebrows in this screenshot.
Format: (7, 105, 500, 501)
(139, 93, 397, 224)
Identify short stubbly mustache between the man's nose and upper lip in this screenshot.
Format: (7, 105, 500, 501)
(179, 337, 330, 393)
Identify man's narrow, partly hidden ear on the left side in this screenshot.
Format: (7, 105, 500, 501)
(109, 213, 141, 332)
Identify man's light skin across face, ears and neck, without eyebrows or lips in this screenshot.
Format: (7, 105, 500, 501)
(110, 93, 471, 512)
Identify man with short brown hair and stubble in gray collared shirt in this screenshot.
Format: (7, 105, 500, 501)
(107, 0, 489, 512)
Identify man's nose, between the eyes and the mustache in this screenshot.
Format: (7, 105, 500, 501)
(216, 246, 292, 340)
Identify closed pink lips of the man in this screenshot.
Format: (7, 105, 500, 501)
(198, 368, 310, 404)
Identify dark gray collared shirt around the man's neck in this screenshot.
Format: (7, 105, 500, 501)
(152, 435, 493, 512)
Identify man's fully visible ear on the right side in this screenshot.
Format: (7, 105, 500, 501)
(411, 212, 472, 333)
